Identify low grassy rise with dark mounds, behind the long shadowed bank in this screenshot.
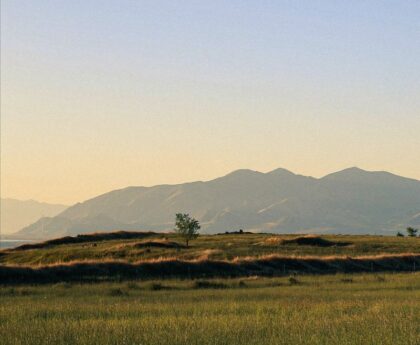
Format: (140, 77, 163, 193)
(0, 231, 420, 266)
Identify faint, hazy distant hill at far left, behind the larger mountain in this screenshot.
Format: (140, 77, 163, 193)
(0, 198, 68, 234)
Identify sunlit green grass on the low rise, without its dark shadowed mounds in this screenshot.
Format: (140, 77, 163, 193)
(0, 234, 420, 265)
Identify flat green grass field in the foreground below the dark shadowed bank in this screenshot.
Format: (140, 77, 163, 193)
(0, 273, 420, 345)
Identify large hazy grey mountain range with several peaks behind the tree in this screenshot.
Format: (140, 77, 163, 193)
(14, 168, 420, 238)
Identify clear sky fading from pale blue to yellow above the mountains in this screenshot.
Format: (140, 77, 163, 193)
(1, 0, 420, 204)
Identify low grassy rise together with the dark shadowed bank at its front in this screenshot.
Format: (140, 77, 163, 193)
(0, 227, 420, 284)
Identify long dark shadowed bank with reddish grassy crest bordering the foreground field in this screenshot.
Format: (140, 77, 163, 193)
(0, 254, 420, 284)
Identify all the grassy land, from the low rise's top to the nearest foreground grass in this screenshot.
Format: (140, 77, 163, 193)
(0, 233, 420, 345)
